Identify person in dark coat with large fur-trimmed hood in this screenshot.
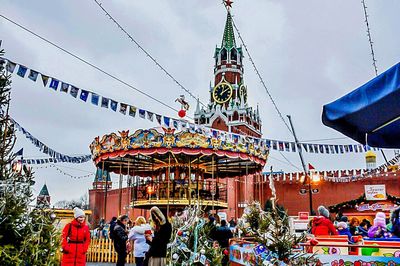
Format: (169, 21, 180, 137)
(145, 206, 172, 266)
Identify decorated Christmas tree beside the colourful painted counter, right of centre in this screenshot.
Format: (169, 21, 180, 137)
(238, 178, 318, 266)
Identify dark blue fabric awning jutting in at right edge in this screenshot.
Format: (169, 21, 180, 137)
(322, 63, 400, 148)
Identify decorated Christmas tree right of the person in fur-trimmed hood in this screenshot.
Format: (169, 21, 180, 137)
(168, 206, 226, 266)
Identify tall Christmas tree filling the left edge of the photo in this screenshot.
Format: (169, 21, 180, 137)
(0, 50, 60, 265)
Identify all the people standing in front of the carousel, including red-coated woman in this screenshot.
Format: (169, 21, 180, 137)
(61, 207, 236, 266)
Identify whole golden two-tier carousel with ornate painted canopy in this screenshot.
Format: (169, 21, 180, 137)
(90, 128, 269, 213)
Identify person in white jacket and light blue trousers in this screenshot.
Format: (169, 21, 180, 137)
(128, 216, 151, 266)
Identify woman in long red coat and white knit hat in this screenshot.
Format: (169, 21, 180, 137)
(61, 207, 90, 266)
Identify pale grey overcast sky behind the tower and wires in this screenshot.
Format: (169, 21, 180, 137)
(0, 0, 400, 203)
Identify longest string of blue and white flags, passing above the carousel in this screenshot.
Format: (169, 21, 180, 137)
(0, 57, 380, 155)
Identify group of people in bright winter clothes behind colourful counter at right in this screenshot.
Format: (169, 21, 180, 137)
(309, 206, 400, 243)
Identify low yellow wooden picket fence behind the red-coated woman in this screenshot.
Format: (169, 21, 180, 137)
(86, 238, 135, 263)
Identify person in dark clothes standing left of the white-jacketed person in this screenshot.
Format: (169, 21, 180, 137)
(113, 215, 129, 266)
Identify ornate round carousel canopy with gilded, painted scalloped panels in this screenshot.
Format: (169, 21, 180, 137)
(90, 128, 269, 177)
